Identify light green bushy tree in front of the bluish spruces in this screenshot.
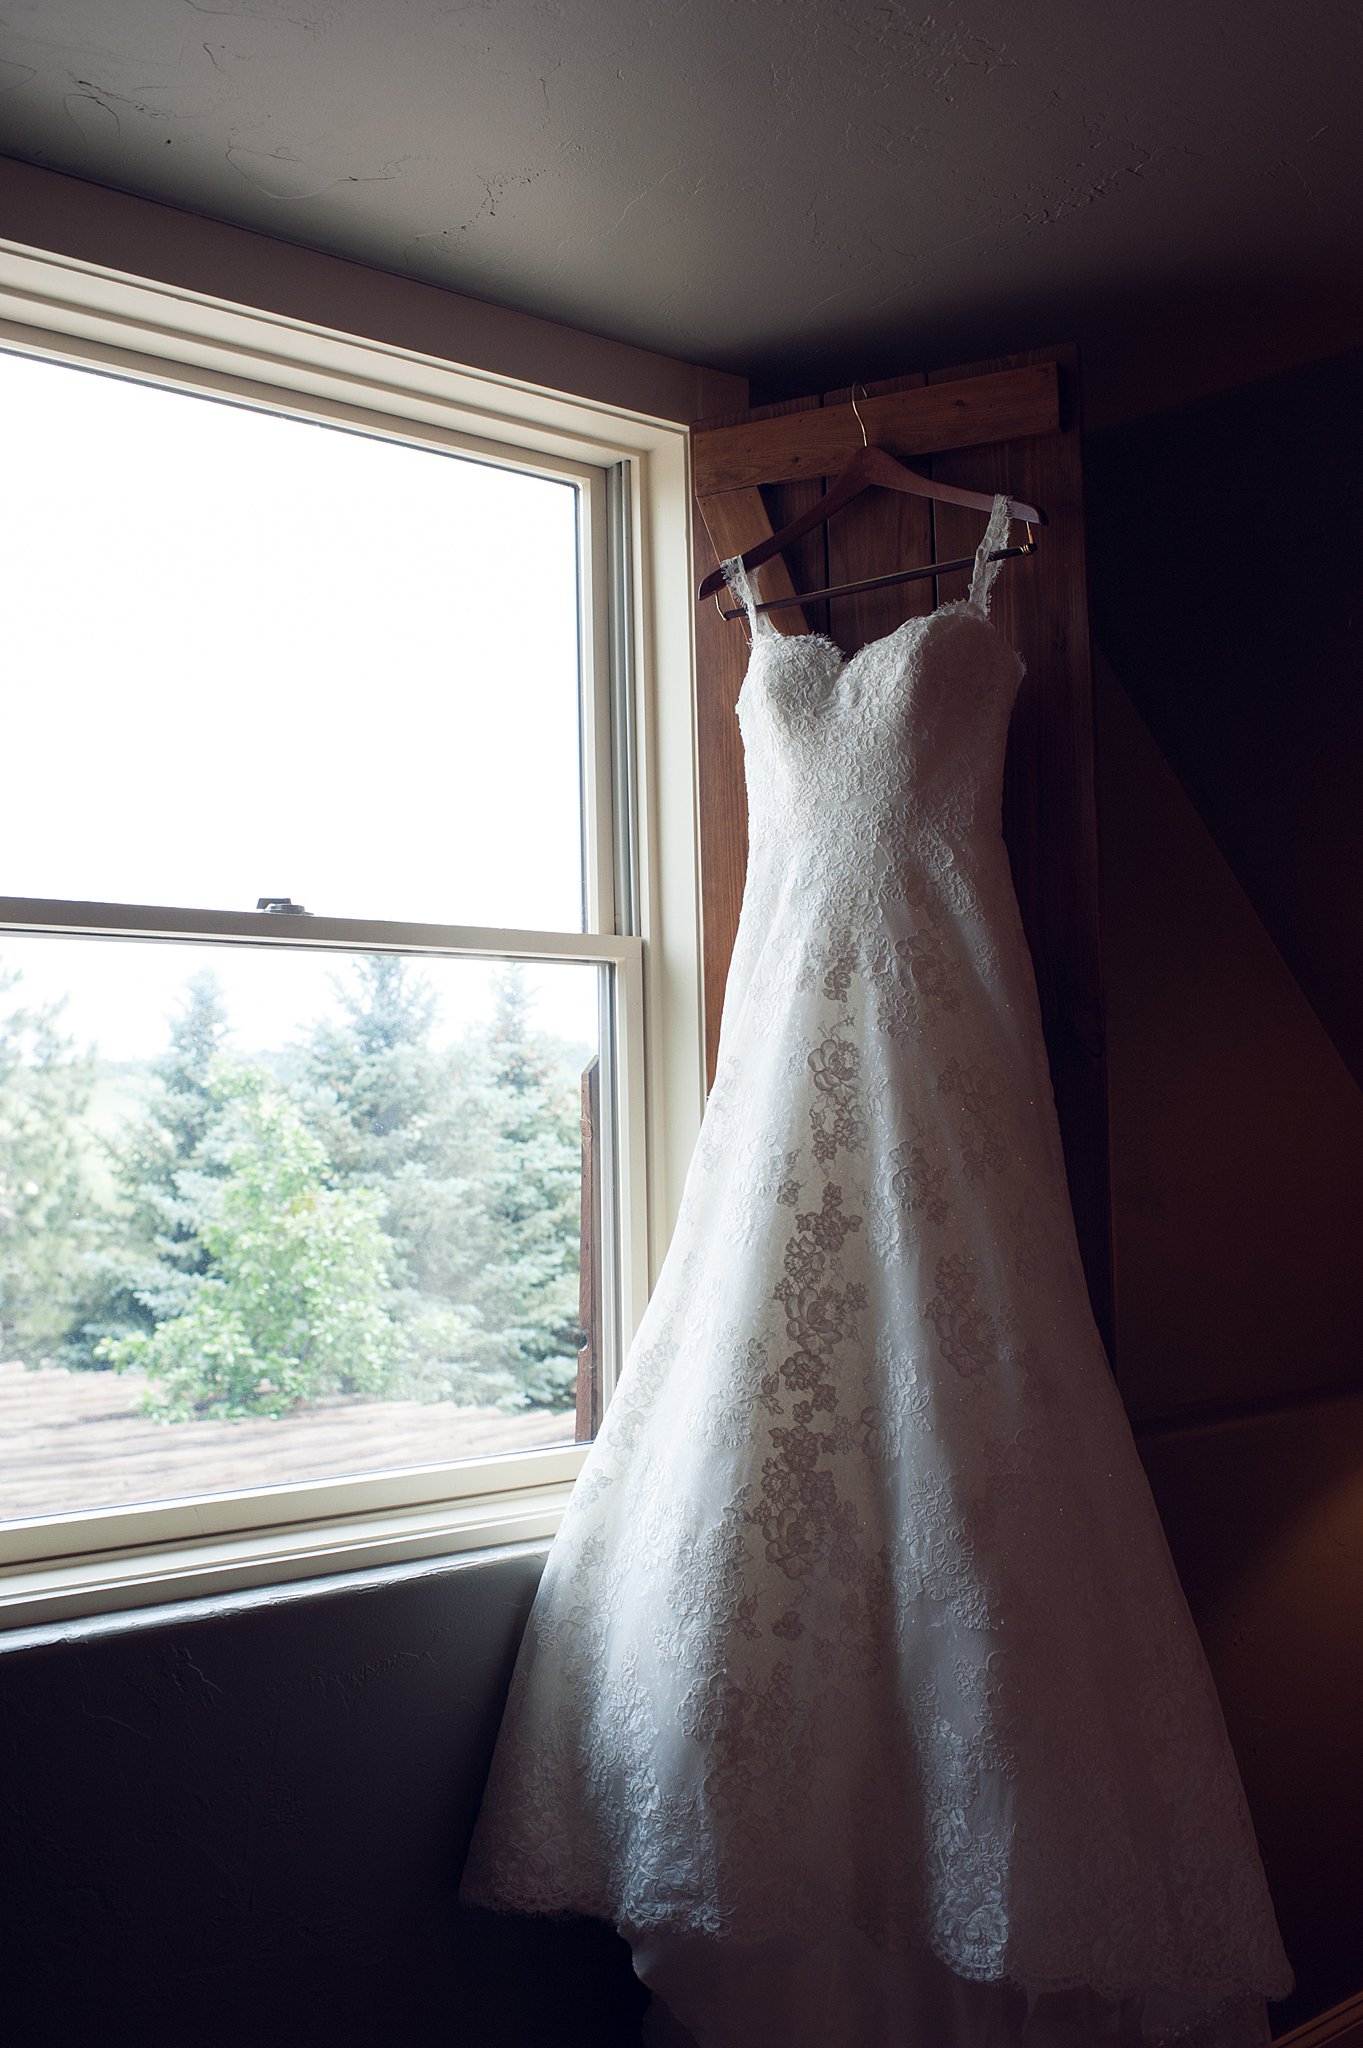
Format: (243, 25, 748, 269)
(96, 1055, 403, 1421)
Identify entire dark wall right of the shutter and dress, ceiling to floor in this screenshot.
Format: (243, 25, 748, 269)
(1087, 344, 1363, 2028)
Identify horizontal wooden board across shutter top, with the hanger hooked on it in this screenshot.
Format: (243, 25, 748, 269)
(692, 362, 1060, 498)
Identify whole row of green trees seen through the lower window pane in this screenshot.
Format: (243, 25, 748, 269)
(0, 954, 581, 1421)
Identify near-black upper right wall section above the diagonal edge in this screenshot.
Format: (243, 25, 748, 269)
(1085, 352, 1363, 1081)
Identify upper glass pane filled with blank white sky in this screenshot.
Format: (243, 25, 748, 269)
(0, 352, 583, 932)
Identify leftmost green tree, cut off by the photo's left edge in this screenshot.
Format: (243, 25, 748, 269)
(0, 969, 94, 1366)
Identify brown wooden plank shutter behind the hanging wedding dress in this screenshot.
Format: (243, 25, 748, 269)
(692, 348, 1111, 1352)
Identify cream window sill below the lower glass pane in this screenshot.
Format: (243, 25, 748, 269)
(0, 1479, 573, 1628)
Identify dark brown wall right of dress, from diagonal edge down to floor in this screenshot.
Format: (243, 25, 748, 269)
(1099, 668, 1363, 2025)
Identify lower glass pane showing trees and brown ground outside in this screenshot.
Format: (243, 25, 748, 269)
(0, 934, 606, 1520)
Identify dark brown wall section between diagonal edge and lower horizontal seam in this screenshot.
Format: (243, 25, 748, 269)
(1097, 662, 1363, 1421)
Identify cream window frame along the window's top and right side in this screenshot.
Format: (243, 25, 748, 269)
(0, 240, 706, 1228)
